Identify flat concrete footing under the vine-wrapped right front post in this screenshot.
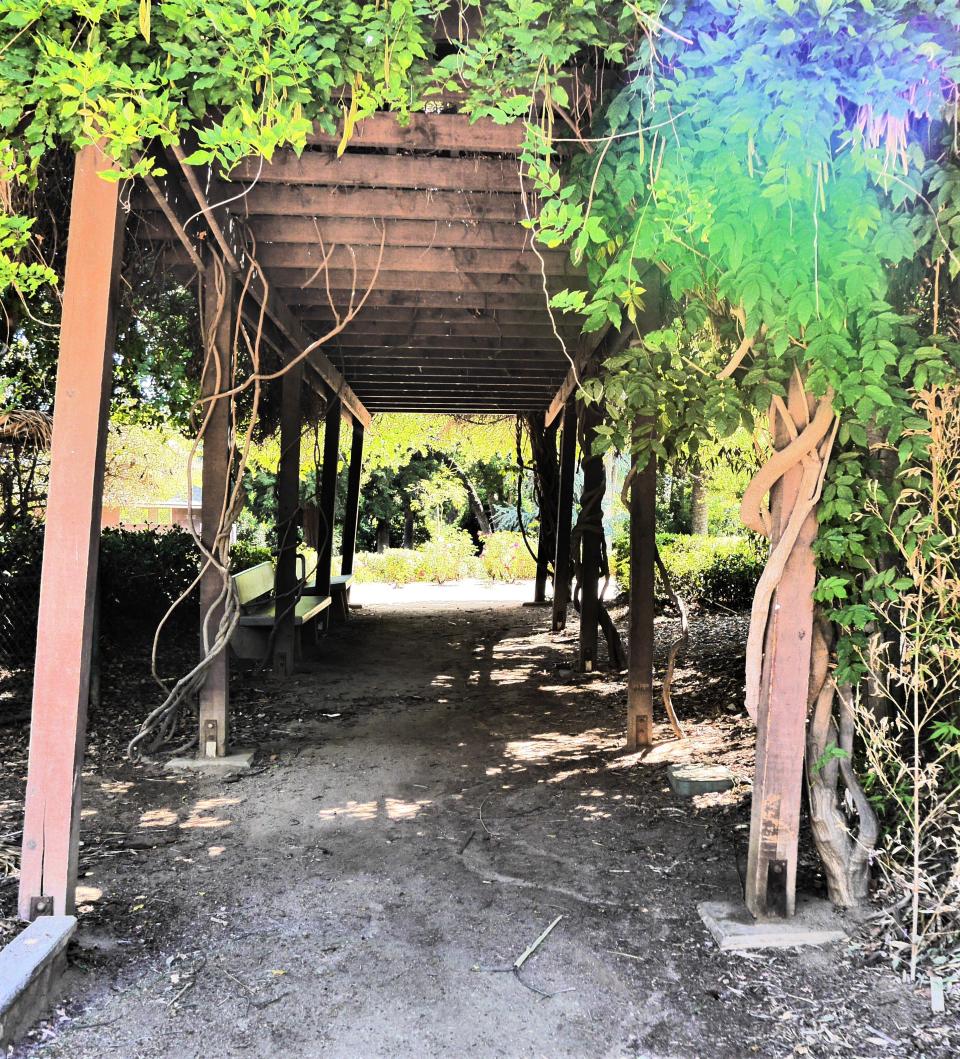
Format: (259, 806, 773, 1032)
(696, 897, 847, 950)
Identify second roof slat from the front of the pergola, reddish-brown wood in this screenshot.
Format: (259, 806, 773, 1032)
(230, 150, 529, 194)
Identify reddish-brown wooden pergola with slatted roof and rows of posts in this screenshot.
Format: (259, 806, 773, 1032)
(13, 105, 805, 936)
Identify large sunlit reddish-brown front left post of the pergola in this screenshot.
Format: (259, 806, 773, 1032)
(18, 146, 124, 919)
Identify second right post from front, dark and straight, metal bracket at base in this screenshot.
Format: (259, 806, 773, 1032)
(627, 438, 656, 751)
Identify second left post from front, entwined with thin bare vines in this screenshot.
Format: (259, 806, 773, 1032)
(199, 265, 236, 757)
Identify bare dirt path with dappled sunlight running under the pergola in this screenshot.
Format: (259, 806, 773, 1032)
(7, 604, 956, 1059)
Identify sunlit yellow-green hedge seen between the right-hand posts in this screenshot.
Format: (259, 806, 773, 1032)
(612, 527, 766, 610)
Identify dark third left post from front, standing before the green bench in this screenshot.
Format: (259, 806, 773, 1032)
(273, 361, 304, 677)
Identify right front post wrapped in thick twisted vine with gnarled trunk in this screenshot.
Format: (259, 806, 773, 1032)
(741, 372, 876, 915)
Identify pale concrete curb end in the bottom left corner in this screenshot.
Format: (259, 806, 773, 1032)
(0, 916, 76, 1048)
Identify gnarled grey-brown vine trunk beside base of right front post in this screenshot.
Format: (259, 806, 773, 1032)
(807, 618, 880, 909)
